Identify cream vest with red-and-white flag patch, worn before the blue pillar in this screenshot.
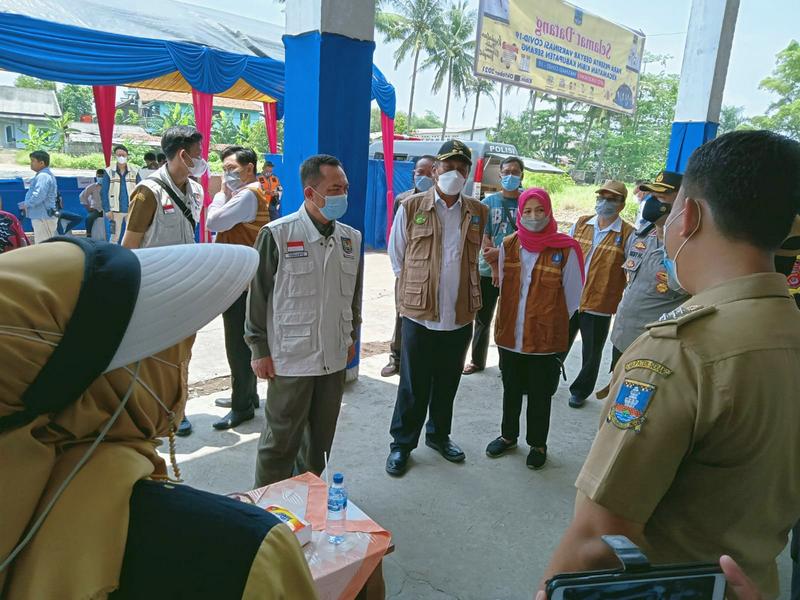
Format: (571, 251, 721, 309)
(267, 206, 361, 377)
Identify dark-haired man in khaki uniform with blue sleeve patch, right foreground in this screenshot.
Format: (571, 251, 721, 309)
(546, 131, 800, 597)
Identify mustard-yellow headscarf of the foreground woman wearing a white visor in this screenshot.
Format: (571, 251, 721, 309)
(0, 242, 193, 600)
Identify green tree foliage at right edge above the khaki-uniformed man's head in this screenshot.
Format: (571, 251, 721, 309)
(753, 40, 800, 140)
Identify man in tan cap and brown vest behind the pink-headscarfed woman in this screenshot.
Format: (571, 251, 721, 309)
(564, 180, 635, 408)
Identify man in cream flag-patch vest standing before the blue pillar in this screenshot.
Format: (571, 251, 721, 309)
(245, 154, 362, 487)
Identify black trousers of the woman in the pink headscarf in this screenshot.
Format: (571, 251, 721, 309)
(499, 348, 561, 448)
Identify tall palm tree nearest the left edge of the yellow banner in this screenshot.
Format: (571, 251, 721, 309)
(422, 0, 475, 139)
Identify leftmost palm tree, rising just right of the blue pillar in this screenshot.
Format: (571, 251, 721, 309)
(375, 0, 442, 133)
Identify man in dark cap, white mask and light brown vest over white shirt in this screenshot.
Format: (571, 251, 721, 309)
(386, 140, 488, 476)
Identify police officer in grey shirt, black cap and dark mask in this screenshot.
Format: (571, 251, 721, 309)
(597, 171, 689, 399)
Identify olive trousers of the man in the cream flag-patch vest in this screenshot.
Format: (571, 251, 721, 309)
(255, 369, 345, 487)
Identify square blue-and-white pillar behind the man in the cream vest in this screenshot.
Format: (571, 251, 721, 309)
(281, 0, 375, 379)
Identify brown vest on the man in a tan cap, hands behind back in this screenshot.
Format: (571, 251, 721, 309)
(574, 216, 633, 315)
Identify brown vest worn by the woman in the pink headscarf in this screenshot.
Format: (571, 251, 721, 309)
(494, 233, 570, 354)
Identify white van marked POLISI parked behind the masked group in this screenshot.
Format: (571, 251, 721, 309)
(369, 140, 564, 198)
